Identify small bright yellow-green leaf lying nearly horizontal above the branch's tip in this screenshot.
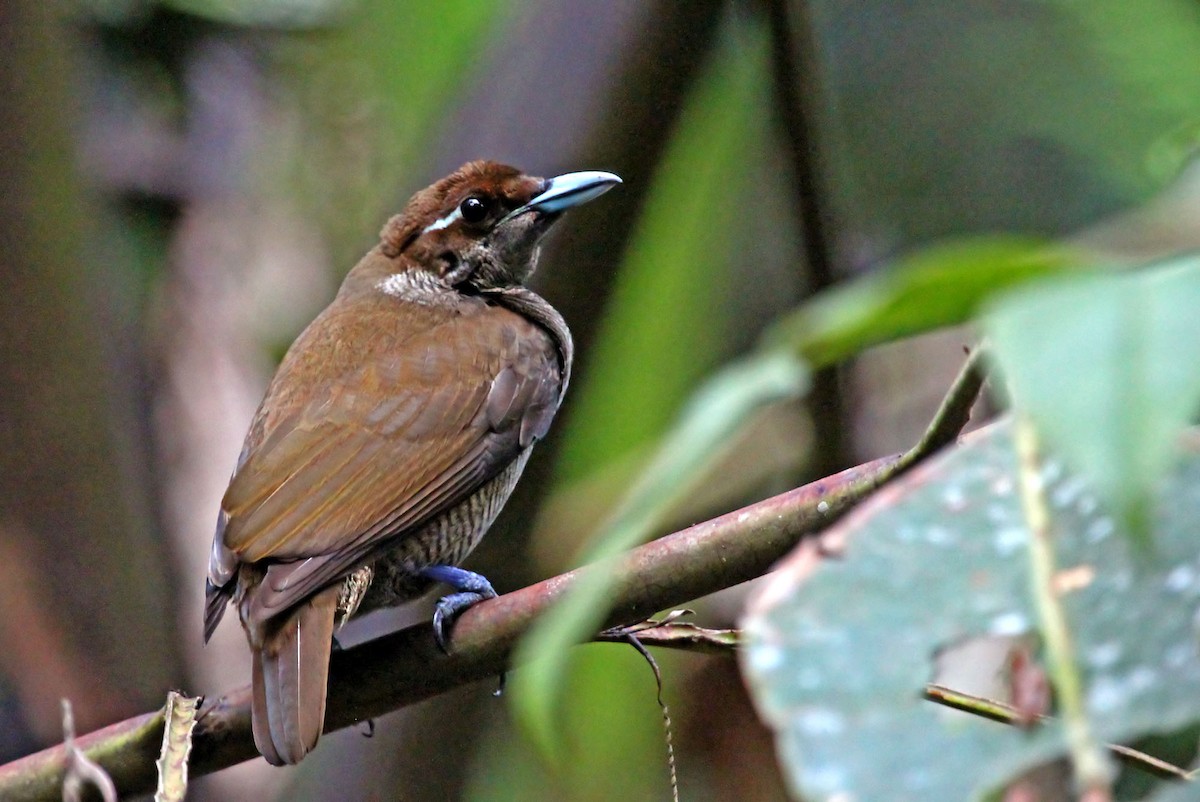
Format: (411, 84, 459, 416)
(767, 235, 1082, 367)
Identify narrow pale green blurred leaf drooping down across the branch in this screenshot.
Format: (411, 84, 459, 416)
(509, 353, 808, 759)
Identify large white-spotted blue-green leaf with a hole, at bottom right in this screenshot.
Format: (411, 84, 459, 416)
(742, 424, 1200, 801)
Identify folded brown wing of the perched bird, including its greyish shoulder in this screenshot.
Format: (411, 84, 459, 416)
(221, 297, 562, 618)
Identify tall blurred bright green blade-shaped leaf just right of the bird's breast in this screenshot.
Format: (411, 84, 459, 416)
(558, 17, 769, 483)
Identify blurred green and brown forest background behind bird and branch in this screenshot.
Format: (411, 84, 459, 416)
(0, 0, 1200, 801)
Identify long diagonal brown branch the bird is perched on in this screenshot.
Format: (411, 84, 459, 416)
(0, 355, 982, 802)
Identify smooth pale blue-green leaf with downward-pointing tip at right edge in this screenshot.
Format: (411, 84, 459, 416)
(988, 256, 1200, 539)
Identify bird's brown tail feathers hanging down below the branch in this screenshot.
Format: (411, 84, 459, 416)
(251, 586, 340, 766)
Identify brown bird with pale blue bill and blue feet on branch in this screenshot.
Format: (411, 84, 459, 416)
(204, 161, 620, 765)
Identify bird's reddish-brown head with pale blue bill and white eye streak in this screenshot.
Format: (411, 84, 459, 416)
(380, 161, 620, 289)
